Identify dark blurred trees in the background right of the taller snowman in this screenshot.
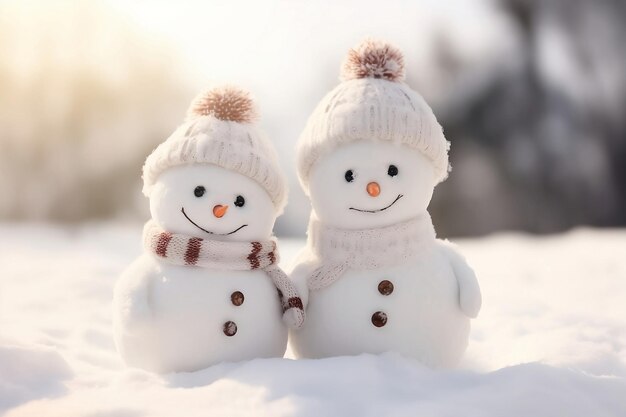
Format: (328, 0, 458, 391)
(433, 0, 626, 235)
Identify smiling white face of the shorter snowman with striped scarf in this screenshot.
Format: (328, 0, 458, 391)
(150, 164, 276, 241)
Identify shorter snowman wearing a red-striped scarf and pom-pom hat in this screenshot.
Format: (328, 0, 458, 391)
(113, 86, 304, 372)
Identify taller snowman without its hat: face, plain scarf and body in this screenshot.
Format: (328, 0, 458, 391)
(290, 140, 481, 368)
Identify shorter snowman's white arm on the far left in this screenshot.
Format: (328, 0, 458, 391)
(113, 255, 156, 329)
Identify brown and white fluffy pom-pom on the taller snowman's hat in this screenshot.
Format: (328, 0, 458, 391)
(341, 39, 404, 81)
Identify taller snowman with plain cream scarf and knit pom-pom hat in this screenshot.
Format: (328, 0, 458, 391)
(290, 40, 481, 367)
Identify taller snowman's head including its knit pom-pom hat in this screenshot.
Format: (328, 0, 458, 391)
(297, 39, 449, 229)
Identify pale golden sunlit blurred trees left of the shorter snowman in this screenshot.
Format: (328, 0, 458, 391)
(0, 1, 189, 221)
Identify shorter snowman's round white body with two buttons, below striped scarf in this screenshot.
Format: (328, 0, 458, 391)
(114, 254, 287, 372)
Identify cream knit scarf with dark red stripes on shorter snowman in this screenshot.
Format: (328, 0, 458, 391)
(143, 220, 304, 329)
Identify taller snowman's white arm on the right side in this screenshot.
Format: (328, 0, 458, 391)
(438, 240, 482, 318)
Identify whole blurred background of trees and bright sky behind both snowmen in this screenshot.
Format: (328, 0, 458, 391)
(0, 0, 626, 236)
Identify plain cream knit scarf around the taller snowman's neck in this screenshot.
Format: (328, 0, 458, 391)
(307, 212, 435, 290)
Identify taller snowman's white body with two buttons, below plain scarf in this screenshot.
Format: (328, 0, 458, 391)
(290, 240, 470, 367)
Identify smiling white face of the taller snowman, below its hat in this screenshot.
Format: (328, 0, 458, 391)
(310, 141, 436, 229)
